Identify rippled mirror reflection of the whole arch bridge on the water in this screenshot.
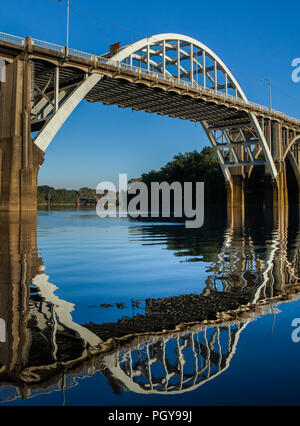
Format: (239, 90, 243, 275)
(0, 210, 300, 402)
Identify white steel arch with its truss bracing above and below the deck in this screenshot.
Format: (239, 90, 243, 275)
(31, 34, 277, 181)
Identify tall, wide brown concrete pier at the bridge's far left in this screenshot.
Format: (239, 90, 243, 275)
(0, 59, 44, 212)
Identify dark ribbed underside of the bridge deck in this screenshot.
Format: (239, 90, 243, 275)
(32, 61, 250, 131)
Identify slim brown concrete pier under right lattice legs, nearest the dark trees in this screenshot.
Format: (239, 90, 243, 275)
(226, 175, 245, 227)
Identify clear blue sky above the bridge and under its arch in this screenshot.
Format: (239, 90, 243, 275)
(0, 0, 300, 188)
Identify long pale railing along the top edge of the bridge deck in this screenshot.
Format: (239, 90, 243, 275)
(0, 32, 300, 124)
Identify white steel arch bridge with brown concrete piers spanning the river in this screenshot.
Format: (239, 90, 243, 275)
(0, 33, 300, 211)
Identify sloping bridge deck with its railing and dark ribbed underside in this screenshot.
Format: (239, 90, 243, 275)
(0, 33, 300, 132)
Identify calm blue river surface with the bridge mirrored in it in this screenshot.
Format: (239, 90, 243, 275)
(0, 209, 300, 406)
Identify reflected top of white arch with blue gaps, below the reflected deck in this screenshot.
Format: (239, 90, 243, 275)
(101, 321, 248, 394)
